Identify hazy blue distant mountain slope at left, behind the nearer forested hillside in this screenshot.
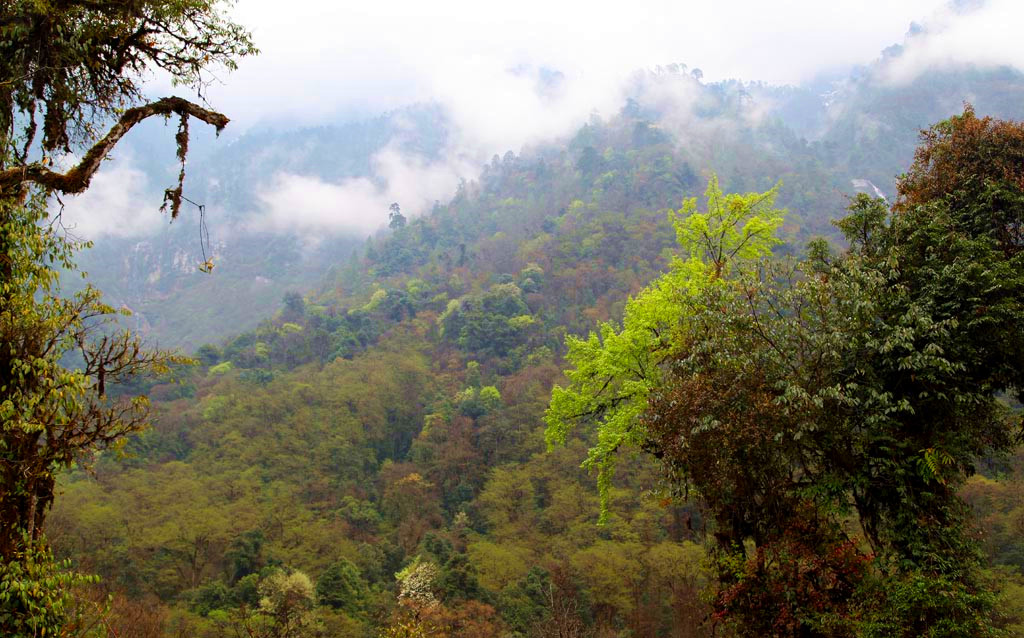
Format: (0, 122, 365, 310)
(79, 108, 445, 349)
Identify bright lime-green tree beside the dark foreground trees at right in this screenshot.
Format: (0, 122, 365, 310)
(546, 177, 783, 514)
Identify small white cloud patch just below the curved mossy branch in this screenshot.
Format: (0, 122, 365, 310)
(50, 151, 168, 240)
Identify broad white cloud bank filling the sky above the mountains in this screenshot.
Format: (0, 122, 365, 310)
(190, 0, 941, 148)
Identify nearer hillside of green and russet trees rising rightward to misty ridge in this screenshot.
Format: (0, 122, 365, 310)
(48, 98, 1022, 636)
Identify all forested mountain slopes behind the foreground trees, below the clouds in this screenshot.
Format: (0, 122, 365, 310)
(47, 43, 1024, 637)
